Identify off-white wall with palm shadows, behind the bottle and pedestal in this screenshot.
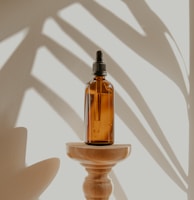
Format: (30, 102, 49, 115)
(0, 0, 193, 200)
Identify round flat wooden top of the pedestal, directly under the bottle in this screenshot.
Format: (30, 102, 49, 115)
(66, 142, 131, 165)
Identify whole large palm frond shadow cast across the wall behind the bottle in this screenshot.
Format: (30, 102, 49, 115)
(0, 0, 193, 200)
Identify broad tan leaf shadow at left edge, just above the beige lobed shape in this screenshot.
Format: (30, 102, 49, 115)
(0, 23, 42, 130)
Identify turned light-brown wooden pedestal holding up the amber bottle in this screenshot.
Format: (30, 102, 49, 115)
(67, 143, 131, 200)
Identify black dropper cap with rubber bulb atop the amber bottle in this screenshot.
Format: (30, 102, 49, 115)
(93, 50, 107, 76)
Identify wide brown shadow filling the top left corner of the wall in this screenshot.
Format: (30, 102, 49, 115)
(0, 0, 74, 41)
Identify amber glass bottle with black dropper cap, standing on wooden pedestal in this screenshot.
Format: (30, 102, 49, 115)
(84, 51, 114, 145)
